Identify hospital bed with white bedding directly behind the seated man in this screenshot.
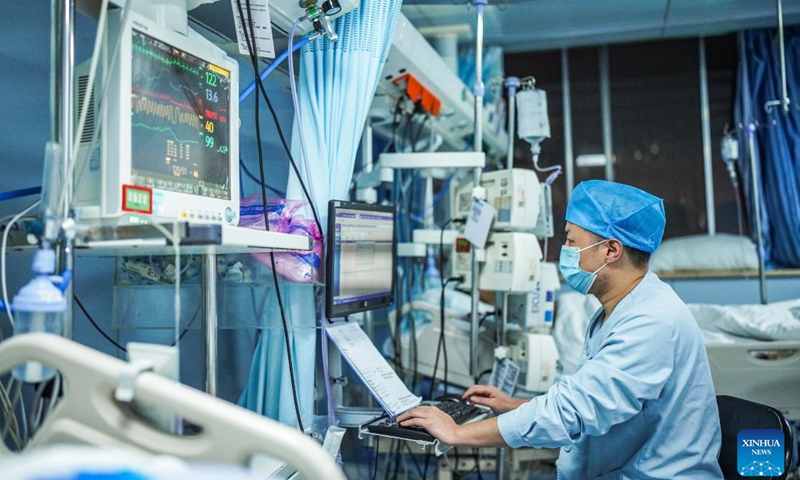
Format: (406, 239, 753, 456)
(553, 290, 800, 421)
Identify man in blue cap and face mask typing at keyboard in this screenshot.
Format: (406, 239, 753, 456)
(398, 180, 723, 480)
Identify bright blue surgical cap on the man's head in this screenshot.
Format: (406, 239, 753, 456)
(567, 180, 667, 253)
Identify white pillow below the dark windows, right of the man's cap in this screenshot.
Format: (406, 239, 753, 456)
(650, 233, 758, 273)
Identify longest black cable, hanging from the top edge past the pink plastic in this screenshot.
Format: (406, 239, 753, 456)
(236, 0, 304, 432)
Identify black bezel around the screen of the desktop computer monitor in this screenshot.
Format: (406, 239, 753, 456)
(325, 200, 397, 319)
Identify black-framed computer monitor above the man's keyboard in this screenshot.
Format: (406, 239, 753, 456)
(325, 200, 396, 318)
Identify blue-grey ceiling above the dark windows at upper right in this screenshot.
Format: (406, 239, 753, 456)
(403, 0, 800, 52)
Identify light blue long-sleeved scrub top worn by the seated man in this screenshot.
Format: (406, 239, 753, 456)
(497, 272, 722, 480)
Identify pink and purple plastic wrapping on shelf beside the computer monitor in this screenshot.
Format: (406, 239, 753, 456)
(239, 195, 323, 283)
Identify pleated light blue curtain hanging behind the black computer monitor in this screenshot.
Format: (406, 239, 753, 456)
(240, 0, 402, 426)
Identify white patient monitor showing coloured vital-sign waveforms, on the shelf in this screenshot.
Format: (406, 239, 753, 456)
(74, 9, 239, 225)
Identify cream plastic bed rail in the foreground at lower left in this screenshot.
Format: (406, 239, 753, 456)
(0, 333, 345, 480)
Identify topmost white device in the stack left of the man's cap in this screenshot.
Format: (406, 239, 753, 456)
(453, 168, 541, 232)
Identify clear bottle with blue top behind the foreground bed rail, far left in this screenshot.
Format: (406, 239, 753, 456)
(11, 250, 67, 383)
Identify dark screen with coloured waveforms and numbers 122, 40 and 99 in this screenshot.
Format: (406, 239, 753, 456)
(130, 28, 231, 200)
